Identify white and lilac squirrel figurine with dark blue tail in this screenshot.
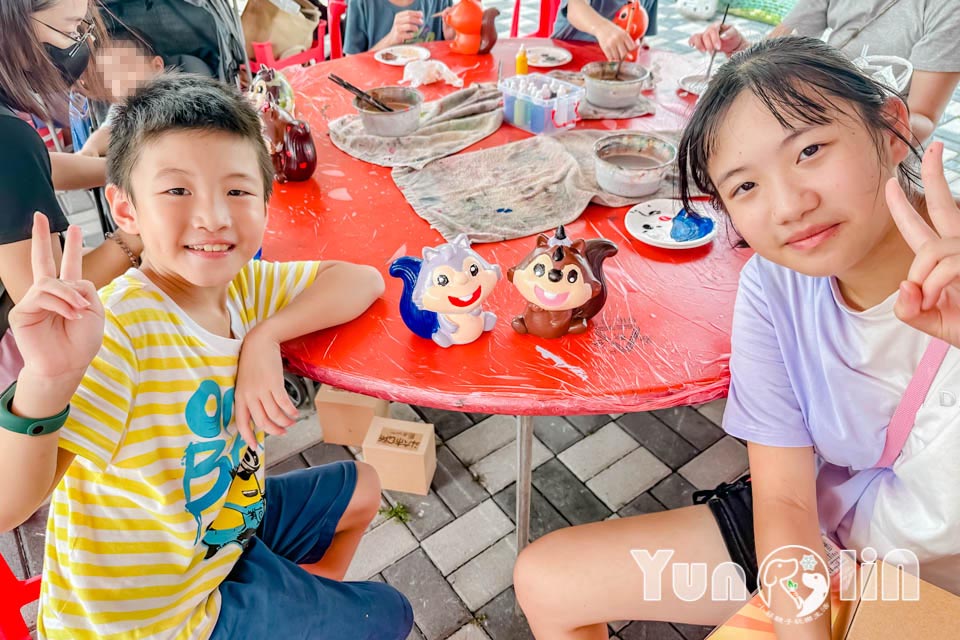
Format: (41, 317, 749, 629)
(390, 234, 501, 347)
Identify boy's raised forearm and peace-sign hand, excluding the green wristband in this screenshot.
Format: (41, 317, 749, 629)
(0, 213, 104, 531)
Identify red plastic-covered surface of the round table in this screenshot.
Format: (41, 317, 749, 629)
(263, 40, 749, 415)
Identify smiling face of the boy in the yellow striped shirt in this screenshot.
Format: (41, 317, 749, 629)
(118, 131, 266, 287)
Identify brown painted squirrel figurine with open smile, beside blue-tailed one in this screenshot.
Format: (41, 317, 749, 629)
(507, 225, 617, 338)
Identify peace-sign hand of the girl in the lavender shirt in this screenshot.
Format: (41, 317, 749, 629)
(886, 142, 960, 347)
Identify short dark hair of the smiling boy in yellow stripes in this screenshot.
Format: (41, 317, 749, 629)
(107, 73, 273, 200)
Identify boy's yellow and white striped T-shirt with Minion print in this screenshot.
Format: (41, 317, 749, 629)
(38, 261, 318, 640)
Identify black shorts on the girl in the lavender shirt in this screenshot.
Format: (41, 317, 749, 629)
(693, 474, 757, 592)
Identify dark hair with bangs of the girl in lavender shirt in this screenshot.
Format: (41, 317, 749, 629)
(677, 36, 919, 246)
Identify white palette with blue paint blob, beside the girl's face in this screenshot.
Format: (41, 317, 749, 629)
(623, 198, 717, 249)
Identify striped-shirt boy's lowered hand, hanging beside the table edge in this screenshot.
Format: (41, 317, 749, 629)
(233, 329, 297, 450)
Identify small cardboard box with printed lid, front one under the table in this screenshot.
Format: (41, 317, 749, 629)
(363, 416, 437, 496)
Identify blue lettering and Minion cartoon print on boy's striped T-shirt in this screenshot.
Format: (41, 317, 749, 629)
(182, 380, 266, 558)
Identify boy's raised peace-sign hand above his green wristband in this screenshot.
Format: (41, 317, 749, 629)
(10, 213, 103, 378)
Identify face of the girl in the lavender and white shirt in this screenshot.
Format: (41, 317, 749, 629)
(709, 92, 907, 278)
